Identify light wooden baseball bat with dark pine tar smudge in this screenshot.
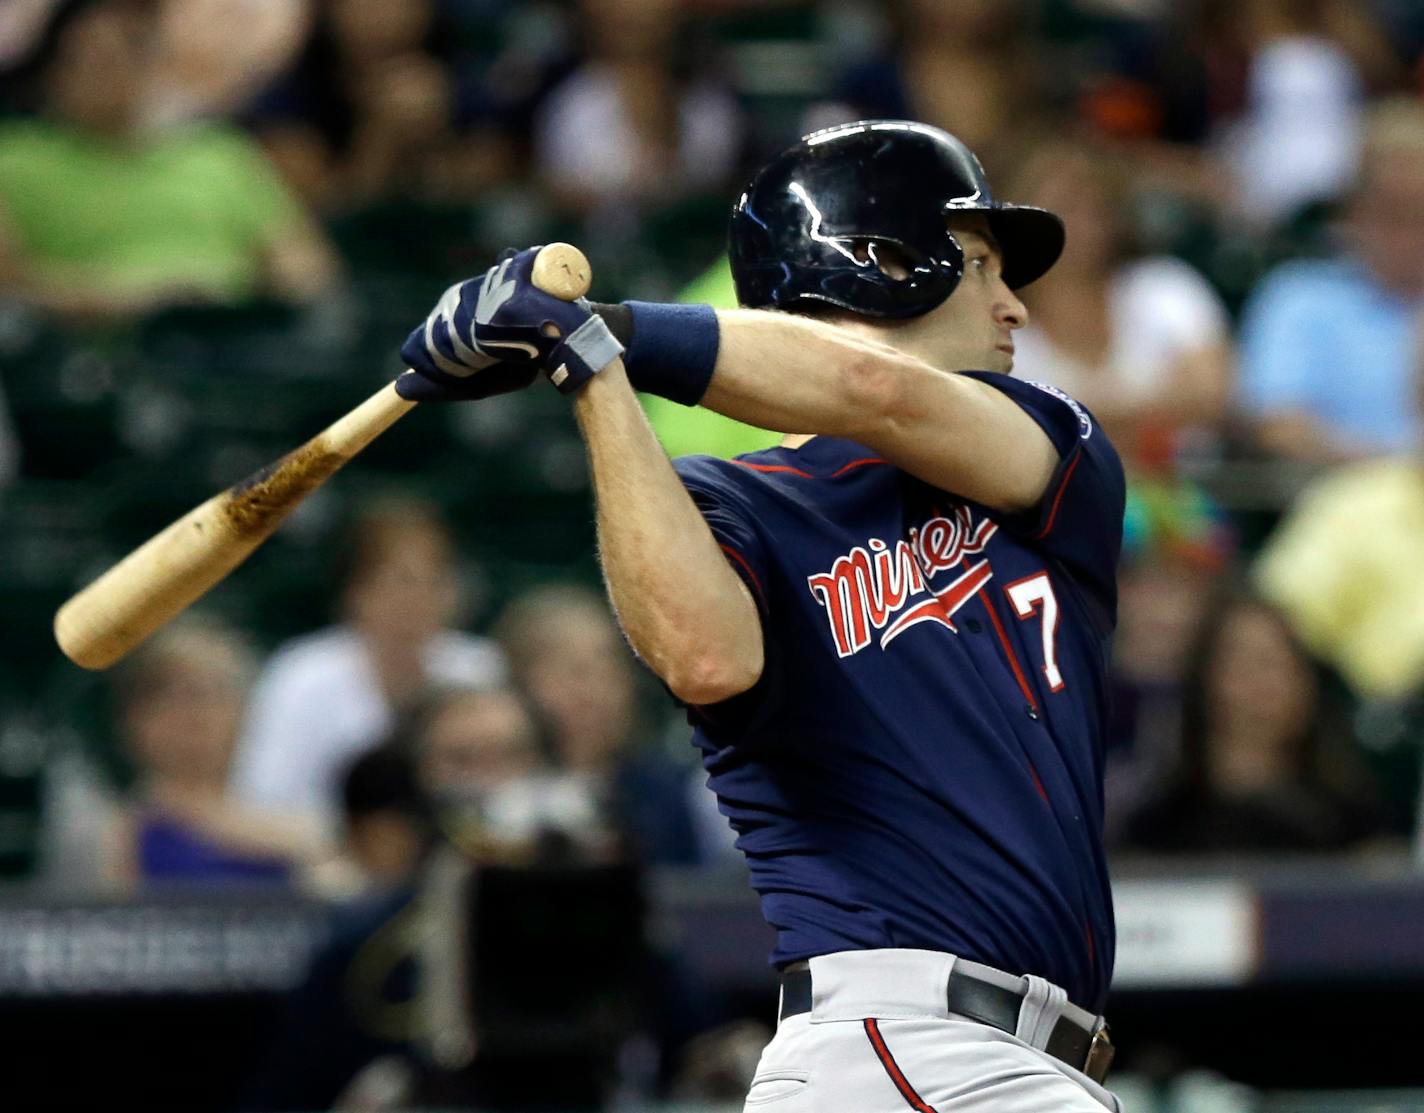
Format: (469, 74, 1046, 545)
(54, 243, 591, 669)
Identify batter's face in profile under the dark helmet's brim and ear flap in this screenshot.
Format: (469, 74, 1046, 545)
(906, 213, 1028, 373)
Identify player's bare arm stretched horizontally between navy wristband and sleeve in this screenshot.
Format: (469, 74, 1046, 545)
(702, 310, 1057, 511)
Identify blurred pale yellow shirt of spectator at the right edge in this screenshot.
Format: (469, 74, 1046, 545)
(1255, 458, 1424, 697)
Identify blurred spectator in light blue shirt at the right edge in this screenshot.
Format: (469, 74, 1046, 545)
(1240, 100, 1424, 463)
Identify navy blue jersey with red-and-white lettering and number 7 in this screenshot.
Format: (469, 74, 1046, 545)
(675, 371, 1124, 1009)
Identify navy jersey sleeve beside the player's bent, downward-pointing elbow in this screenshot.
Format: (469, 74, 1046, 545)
(672, 455, 783, 742)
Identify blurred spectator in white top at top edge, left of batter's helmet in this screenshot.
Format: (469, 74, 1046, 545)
(534, 0, 743, 211)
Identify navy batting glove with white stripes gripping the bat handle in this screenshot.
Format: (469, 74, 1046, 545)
(396, 248, 622, 401)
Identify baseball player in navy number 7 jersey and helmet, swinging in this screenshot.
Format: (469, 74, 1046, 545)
(397, 121, 1124, 1113)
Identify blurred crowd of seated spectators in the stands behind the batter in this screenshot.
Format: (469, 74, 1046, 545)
(0, 0, 1424, 1104)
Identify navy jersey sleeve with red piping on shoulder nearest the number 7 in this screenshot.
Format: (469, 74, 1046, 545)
(963, 371, 1126, 632)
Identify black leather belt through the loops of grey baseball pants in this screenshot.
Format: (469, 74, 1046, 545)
(782, 962, 1112, 1085)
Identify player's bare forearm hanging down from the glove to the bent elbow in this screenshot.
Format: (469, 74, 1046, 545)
(575, 362, 762, 703)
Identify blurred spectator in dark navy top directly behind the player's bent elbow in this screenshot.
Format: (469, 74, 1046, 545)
(496, 584, 726, 865)
